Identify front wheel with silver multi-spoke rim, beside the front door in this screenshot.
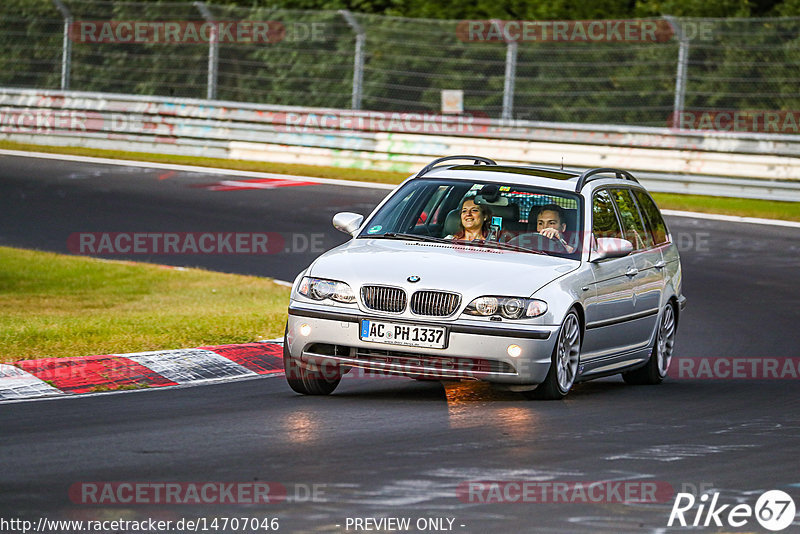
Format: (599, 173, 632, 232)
(523, 309, 582, 400)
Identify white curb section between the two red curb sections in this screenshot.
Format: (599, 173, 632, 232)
(126, 349, 258, 384)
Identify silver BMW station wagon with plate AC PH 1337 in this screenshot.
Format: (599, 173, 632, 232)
(284, 156, 686, 399)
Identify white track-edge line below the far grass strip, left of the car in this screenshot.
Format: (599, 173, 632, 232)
(0, 149, 397, 190)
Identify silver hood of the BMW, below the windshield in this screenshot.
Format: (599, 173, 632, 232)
(306, 239, 580, 296)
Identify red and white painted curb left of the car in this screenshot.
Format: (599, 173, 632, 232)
(0, 340, 283, 401)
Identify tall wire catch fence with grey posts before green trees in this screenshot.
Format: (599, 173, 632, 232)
(0, 0, 800, 129)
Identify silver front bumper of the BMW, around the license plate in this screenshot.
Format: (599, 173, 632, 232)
(286, 306, 559, 384)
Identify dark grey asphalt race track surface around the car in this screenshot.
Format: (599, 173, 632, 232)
(0, 156, 800, 533)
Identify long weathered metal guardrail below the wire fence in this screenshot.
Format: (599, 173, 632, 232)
(0, 89, 800, 200)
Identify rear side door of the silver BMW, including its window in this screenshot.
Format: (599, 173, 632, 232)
(610, 188, 664, 345)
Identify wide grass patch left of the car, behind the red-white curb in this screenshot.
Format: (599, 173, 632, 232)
(0, 247, 289, 362)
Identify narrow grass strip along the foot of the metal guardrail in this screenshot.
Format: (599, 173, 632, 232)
(0, 141, 800, 221)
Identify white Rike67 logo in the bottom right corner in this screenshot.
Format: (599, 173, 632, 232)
(667, 490, 795, 532)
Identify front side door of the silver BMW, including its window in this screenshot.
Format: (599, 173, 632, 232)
(581, 189, 636, 361)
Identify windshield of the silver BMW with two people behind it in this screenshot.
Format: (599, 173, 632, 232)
(358, 178, 583, 258)
